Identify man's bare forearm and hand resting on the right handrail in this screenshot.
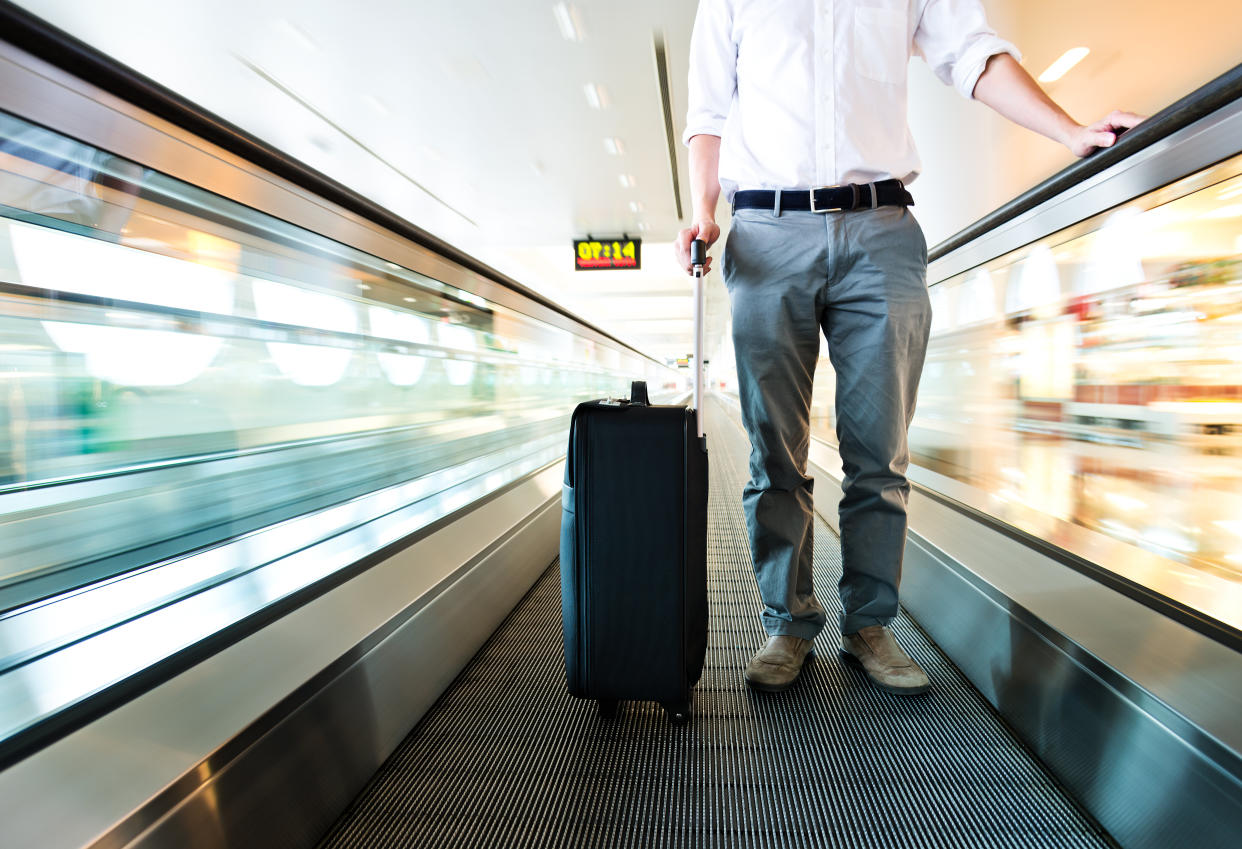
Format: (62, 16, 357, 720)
(974, 53, 1143, 156)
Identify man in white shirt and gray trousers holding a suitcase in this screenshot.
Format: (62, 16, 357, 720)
(677, 0, 1140, 695)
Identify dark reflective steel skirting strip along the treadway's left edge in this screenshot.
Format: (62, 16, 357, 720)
(129, 501, 560, 849)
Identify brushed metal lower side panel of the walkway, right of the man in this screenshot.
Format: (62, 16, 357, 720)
(811, 441, 1242, 849)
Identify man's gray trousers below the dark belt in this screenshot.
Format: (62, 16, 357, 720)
(722, 206, 932, 639)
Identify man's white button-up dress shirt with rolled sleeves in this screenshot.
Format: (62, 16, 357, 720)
(683, 0, 1021, 200)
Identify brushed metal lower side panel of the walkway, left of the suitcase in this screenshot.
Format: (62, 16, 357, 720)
(0, 463, 563, 849)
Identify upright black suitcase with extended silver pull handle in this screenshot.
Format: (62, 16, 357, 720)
(560, 238, 708, 722)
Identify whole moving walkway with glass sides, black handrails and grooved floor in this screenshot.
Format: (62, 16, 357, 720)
(0, 13, 1242, 847)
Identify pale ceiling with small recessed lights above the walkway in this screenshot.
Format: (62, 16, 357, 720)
(12, 0, 1238, 367)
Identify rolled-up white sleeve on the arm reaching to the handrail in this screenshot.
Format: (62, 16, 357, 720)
(914, 0, 1022, 99)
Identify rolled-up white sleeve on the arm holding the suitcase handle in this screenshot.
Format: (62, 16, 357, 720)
(682, 0, 738, 144)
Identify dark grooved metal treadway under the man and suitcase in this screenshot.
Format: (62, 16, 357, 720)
(320, 434, 1110, 849)
